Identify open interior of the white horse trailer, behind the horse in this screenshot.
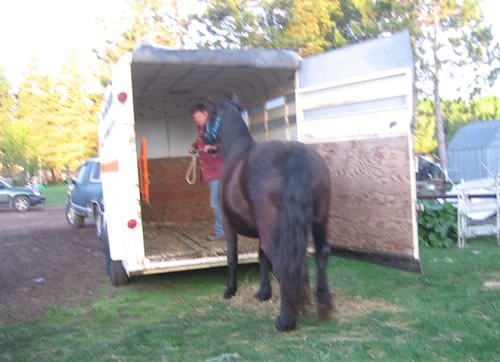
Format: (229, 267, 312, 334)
(131, 44, 301, 270)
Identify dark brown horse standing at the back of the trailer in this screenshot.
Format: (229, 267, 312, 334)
(216, 97, 332, 331)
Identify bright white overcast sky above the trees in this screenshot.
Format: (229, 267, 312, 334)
(0, 0, 500, 98)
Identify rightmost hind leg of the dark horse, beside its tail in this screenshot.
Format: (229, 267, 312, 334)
(313, 222, 334, 320)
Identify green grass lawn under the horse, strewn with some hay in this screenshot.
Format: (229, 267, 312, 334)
(0, 238, 500, 361)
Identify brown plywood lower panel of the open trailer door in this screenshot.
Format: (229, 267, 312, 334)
(313, 137, 414, 256)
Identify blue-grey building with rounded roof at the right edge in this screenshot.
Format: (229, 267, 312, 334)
(447, 120, 500, 182)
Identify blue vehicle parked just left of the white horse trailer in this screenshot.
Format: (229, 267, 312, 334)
(66, 158, 104, 237)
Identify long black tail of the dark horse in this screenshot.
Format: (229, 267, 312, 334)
(279, 151, 313, 316)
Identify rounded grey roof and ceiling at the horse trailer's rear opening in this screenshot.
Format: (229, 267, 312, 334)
(132, 43, 302, 106)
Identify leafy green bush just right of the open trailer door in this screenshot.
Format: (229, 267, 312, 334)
(418, 199, 458, 248)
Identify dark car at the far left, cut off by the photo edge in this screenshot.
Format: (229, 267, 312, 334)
(0, 178, 45, 212)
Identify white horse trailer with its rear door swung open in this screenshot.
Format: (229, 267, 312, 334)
(99, 32, 421, 285)
